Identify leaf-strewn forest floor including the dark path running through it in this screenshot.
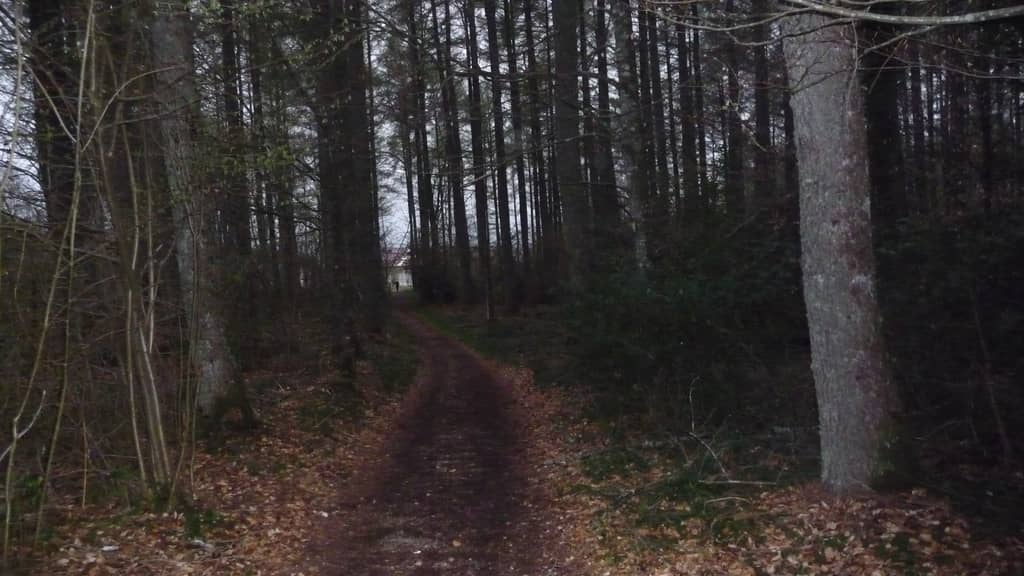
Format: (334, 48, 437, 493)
(16, 308, 1024, 576)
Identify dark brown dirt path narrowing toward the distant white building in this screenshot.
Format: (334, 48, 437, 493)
(319, 314, 581, 576)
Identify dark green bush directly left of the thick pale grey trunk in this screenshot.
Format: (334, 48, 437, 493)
(568, 226, 815, 428)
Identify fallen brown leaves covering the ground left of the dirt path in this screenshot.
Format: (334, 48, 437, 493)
(29, 360, 403, 576)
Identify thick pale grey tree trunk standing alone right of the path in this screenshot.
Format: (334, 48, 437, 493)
(784, 15, 899, 492)
